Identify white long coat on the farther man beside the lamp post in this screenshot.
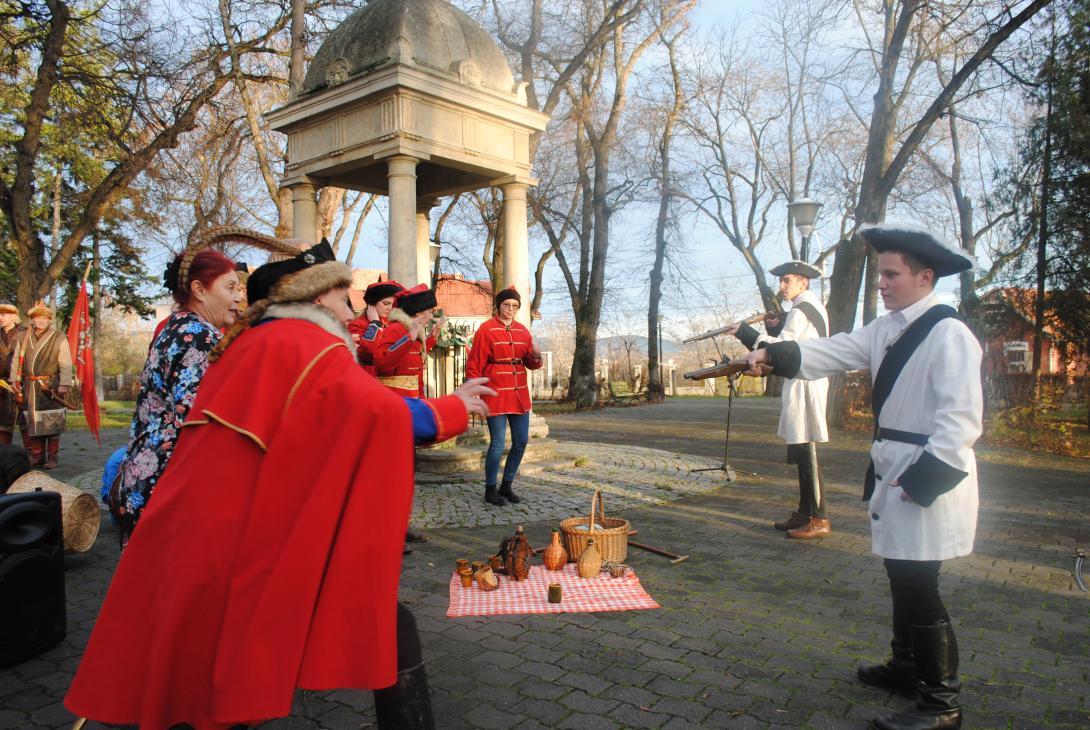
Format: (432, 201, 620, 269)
(754, 291, 828, 443)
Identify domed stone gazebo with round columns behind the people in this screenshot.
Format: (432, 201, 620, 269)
(267, 0, 548, 325)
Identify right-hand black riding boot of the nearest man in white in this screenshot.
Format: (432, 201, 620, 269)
(872, 621, 961, 730)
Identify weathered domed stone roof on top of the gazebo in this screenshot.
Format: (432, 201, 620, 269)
(303, 0, 514, 95)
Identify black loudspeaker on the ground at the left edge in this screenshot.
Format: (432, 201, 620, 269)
(0, 491, 68, 667)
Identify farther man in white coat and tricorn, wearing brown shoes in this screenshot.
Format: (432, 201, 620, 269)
(726, 261, 831, 539)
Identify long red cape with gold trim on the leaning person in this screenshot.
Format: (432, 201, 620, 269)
(64, 319, 413, 730)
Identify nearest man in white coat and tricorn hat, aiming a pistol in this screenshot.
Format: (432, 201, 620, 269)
(747, 224, 983, 730)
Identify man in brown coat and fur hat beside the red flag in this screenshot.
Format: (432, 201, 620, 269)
(11, 304, 72, 469)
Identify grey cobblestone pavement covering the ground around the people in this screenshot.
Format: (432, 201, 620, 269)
(0, 399, 1090, 730)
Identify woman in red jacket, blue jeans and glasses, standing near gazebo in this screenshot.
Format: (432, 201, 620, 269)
(465, 287, 542, 507)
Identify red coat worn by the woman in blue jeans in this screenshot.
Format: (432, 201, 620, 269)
(465, 317, 542, 415)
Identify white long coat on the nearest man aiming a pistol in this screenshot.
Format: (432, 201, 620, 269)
(798, 294, 983, 560)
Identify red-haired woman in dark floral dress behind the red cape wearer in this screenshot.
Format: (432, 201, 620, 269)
(109, 248, 242, 545)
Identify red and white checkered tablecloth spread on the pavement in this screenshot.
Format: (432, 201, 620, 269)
(447, 563, 659, 618)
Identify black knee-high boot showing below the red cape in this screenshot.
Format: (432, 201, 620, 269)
(375, 603, 435, 730)
